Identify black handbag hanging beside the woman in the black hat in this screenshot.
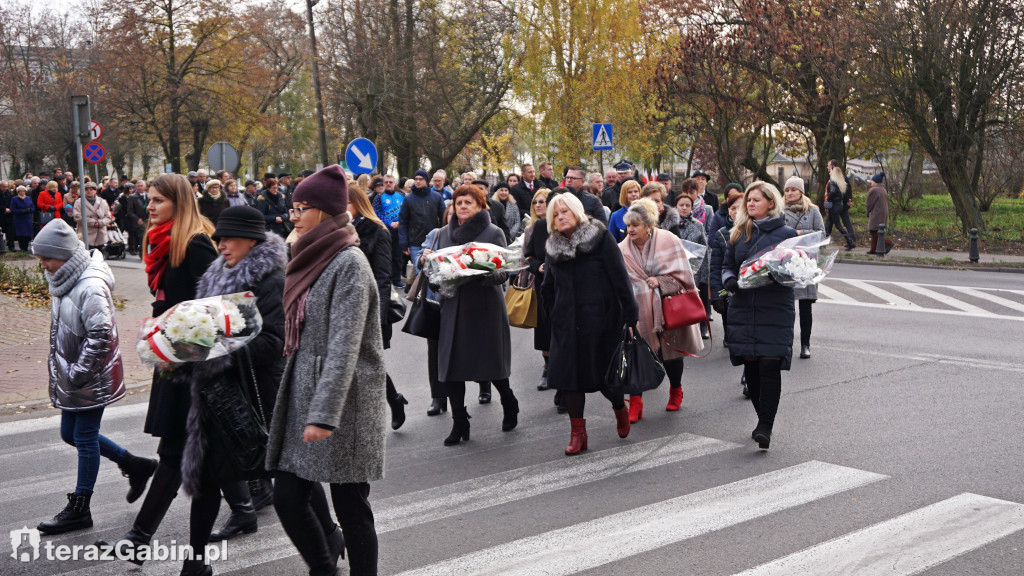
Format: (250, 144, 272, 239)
(200, 348, 269, 472)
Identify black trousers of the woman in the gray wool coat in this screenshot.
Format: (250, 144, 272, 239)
(273, 471, 378, 576)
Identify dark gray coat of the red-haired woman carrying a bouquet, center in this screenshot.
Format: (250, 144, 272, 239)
(437, 218, 512, 382)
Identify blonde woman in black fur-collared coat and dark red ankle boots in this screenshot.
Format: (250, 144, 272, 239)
(541, 194, 638, 456)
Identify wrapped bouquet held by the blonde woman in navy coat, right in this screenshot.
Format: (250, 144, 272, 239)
(738, 232, 838, 288)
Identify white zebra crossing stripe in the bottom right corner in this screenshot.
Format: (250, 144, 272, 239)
(738, 494, 1024, 576)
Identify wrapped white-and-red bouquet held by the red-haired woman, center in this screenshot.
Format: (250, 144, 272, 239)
(423, 242, 526, 298)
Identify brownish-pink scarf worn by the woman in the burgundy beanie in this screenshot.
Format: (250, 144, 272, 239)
(284, 212, 359, 356)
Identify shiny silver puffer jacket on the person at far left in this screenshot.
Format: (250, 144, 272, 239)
(46, 246, 125, 411)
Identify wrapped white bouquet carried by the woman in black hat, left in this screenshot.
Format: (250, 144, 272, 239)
(135, 292, 263, 365)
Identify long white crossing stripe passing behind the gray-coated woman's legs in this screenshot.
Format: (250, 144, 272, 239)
(51, 426, 739, 576)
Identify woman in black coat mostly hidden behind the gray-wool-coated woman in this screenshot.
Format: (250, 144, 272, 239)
(348, 186, 409, 430)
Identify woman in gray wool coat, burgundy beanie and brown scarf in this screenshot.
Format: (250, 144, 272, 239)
(266, 165, 386, 576)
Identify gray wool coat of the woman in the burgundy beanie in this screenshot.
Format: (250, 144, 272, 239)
(266, 246, 386, 484)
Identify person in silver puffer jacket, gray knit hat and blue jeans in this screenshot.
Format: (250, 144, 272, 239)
(32, 218, 157, 534)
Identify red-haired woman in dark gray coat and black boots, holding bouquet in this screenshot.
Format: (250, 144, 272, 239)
(437, 184, 519, 446)
